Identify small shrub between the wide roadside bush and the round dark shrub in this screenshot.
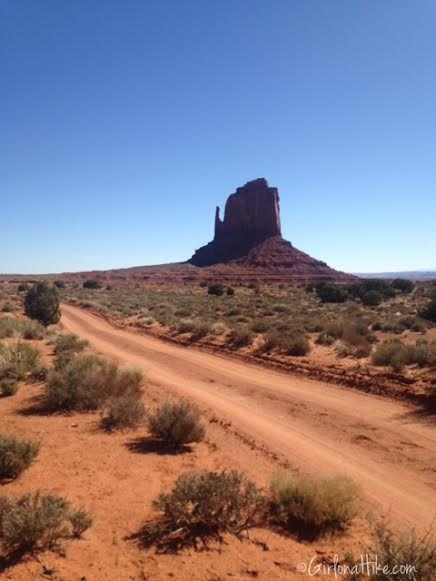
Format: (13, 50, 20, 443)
(101, 395, 145, 431)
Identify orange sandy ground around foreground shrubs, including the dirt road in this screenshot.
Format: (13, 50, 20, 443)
(0, 306, 436, 581)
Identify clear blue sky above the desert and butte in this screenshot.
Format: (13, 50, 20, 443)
(0, 0, 436, 273)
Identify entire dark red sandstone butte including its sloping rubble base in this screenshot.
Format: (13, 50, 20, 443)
(189, 178, 351, 279)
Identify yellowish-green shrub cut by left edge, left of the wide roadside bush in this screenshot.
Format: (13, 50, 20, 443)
(0, 343, 44, 381)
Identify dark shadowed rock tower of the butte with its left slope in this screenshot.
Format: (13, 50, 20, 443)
(190, 178, 281, 266)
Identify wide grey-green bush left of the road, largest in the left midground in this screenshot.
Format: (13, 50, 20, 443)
(45, 354, 143, 411)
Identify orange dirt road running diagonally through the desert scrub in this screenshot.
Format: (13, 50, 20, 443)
(62, 305, 436, 529)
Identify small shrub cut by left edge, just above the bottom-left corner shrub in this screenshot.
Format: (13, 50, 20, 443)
(0, 434, 39, 480)
